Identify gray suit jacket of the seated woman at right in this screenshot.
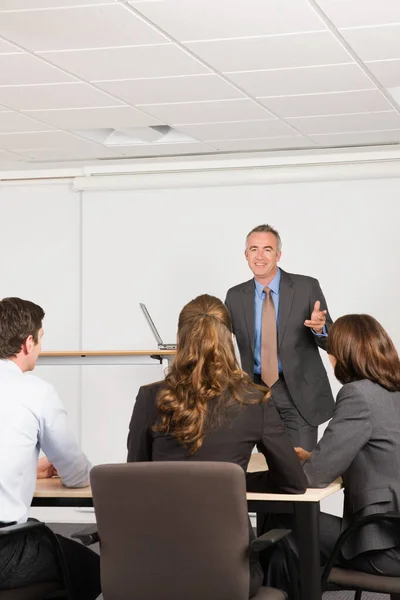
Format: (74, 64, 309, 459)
(304, 379, 400, 559)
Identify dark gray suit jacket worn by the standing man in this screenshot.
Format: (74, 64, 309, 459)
(225, 269, 334, 425)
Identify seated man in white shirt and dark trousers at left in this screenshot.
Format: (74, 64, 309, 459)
(0, 298, 101, 600)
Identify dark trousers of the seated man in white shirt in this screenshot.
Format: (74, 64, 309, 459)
(0, 531, 101, 600)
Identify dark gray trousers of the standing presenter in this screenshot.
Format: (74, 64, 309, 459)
(254, 373, 318, 452)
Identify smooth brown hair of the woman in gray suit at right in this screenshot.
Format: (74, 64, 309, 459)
(327, 315, 400, 392)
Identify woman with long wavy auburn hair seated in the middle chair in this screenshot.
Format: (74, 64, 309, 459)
(128, 294, 306, 596)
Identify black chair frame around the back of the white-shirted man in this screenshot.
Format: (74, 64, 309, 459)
(0, 519, 73, 600)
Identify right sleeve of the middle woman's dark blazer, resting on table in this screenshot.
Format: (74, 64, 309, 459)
(246, 399, 307, 494)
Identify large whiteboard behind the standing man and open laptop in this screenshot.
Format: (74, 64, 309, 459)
(82, 179, 400, 349)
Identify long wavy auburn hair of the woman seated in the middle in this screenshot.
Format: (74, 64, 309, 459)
(154, 294, 270, 454)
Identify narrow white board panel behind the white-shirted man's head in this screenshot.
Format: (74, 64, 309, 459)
(0, 182, 81, 350)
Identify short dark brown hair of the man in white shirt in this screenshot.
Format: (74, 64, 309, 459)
(0, 298, 44, 358)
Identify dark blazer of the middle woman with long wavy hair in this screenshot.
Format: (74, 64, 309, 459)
(128, 381, 307, 597)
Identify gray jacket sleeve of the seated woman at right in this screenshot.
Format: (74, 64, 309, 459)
(303, 384, 372, 488)
